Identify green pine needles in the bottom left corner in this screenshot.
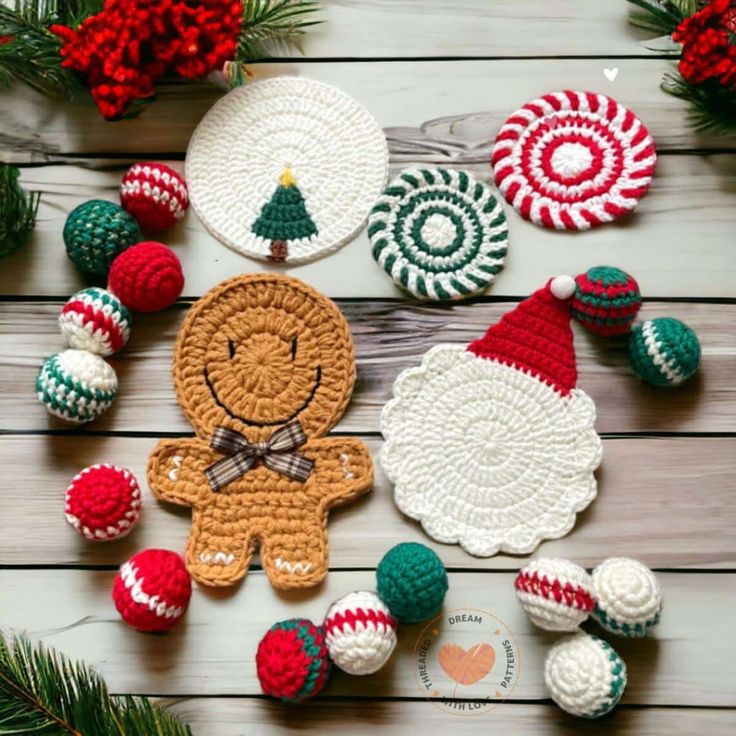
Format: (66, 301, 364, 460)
(0, 635, 192, 736)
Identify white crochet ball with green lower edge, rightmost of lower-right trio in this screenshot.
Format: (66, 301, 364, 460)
(593, 557, 662, 637)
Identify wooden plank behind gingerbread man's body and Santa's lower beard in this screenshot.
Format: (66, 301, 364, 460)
(0, 435, 736, 568)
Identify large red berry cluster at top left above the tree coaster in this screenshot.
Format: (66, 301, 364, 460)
(51, 0, 243, 119)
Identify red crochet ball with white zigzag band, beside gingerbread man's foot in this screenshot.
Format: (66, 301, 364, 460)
(112, 549, 192, 631)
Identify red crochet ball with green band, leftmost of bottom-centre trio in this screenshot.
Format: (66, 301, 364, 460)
(256, 618, 330, 702)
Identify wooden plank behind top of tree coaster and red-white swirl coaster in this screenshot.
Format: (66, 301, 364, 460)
(0, 61, 736, 161)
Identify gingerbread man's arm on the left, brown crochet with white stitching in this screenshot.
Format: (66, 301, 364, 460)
(147, 439, 216, 506)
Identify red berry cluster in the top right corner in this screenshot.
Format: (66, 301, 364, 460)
(672, 0, 736, 86)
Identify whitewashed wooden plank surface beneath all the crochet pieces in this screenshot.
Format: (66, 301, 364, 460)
(0, 0, 736, 736)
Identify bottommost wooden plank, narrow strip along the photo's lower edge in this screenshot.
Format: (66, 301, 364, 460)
(162, 698, 736, 736)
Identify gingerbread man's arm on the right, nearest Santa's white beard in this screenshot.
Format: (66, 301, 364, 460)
(305, 437, 373, 506)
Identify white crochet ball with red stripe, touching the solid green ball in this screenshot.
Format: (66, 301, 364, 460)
(324, 590, 396, 675)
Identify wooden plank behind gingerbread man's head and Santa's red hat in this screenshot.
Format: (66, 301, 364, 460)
(0, 302, 736, 434)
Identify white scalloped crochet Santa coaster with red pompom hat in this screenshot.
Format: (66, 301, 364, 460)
(381, 277, 602, 557)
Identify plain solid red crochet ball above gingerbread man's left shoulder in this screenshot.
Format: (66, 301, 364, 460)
(107, 241, 184, 312)
